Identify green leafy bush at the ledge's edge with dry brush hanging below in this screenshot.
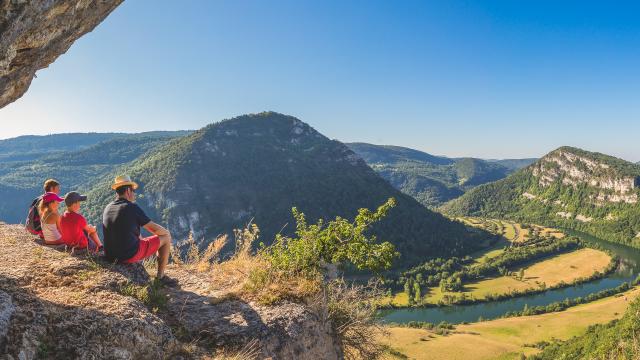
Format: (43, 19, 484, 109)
(258, 199, 399, 359)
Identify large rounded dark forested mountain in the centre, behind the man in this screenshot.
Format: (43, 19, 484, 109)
(81, 112, 490, 265)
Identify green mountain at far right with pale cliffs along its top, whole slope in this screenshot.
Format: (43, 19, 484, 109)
(442, 147, 640, 246)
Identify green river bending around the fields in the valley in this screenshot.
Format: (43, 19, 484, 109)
(381, 230, 640, 324)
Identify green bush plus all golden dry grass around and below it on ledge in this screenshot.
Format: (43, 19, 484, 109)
(202, 199, 399, 359)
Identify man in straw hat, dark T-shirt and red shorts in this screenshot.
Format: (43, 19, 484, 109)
(102, 175, 175, 285)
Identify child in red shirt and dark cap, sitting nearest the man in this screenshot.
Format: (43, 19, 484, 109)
(60, 191, 102, 252)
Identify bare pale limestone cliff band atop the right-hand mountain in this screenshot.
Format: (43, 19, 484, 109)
(532, 148, 640, 204)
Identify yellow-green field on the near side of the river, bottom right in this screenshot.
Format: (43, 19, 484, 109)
(381, 288, 640, 360)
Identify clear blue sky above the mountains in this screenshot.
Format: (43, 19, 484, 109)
(0, 0, 640, 161)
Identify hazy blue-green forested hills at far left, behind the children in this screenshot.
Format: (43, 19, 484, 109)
(0, 131, 190, 223)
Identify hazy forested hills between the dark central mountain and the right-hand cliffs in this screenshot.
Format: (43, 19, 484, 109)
(347, 143, 531, 207)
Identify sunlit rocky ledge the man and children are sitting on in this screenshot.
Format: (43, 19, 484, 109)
(0, 224, 342, 359)
